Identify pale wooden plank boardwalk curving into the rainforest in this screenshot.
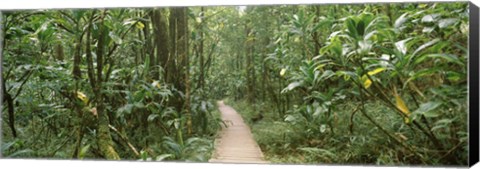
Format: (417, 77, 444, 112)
(209, 101, 268, 163)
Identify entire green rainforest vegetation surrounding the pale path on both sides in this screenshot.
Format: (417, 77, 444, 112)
(0, 2, 469, 165)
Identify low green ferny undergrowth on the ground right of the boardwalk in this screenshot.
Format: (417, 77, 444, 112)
(226, 99, 466, 165)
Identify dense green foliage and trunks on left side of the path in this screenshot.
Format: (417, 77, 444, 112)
(2, 8, 220, 161)
